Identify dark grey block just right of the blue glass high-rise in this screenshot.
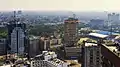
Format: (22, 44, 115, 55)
(28, 36, 40, 57)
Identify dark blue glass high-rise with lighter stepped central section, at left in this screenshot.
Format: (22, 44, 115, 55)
(8, 21, 26, 54)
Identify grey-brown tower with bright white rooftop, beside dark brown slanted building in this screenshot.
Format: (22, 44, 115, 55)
(82, 43, 101, 67)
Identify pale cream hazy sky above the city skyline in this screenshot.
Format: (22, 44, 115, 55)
(0, 0, 120, 11)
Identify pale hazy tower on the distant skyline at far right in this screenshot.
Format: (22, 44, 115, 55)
(108, 13, 119, 24)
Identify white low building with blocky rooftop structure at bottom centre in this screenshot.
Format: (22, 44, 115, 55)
(31, 51, 68, 67)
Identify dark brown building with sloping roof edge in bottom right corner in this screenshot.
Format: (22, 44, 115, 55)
(100, 44, 120, 67)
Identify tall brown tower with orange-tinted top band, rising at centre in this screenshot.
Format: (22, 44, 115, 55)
(64, 18, 78, 47)
